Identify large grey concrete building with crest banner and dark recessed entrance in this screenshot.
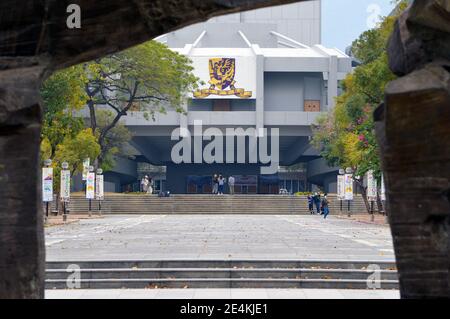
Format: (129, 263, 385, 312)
(96, 1, 351, 193)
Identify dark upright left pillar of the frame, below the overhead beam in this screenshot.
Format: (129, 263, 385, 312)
(0, 58, 45, 299)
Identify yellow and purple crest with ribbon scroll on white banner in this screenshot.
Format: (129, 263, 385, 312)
(194, 58, 252, 99)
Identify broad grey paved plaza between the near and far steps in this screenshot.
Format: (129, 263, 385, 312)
(46, 215, 394, 261)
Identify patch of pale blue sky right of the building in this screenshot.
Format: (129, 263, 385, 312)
(322, 0, 394, 51)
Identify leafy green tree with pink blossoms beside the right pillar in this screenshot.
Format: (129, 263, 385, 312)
(312, 1, 406, 211)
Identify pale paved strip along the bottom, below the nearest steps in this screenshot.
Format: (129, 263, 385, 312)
(45, 289, 400, 299)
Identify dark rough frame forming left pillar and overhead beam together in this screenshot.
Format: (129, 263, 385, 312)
(0, 0, 302, 298)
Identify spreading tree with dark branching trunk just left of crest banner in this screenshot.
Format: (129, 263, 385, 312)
(84, 41, 198, 167)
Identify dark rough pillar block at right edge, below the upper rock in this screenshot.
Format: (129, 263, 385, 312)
(376, 62, 450, 298)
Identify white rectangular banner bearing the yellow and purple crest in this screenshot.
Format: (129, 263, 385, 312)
(189, 55, 256, 99)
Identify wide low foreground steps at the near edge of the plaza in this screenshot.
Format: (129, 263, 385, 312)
(45, 260, 398, 289)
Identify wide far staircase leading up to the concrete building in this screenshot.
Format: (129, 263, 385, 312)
(69, 194, 366, 214)
